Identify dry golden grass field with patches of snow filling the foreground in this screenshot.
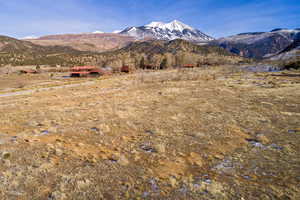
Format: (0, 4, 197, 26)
(0, 66, 300, 200)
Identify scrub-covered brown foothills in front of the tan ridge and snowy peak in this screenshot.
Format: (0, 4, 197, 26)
(0, 36, 244, 68)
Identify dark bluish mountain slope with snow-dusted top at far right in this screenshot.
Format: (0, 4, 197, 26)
(211, 29, 300, 59)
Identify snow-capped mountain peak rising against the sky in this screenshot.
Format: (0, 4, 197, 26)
(120, 20, 213, 42)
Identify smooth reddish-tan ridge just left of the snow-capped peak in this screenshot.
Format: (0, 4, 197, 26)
(27, 33, 135, 52)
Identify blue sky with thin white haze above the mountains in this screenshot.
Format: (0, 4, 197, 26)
(0, 0, 300, 38)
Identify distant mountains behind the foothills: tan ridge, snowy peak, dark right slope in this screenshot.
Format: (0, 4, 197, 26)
(21, 20, 300, 59)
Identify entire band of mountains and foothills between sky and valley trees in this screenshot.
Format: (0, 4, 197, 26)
(0, 20, 300, 65)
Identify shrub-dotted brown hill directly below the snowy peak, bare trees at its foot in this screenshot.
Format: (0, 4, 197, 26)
(87, 39, 245, 68)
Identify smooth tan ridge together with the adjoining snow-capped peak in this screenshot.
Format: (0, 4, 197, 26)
(25, 20, 213, 52)
